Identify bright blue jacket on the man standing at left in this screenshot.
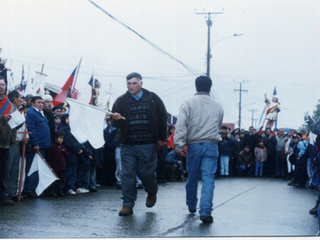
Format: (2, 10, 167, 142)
(26, 107, 51, 148)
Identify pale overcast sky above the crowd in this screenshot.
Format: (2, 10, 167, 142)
(0, 0, 320, 129)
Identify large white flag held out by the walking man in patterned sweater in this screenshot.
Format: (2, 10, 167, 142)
(67, 98, 108, 149)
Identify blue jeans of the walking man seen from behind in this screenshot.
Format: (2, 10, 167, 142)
(186, 142, 219, 216)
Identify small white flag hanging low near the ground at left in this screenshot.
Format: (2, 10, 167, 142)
(28, 153, 59, 196)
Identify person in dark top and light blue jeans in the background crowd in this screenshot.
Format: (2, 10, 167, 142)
(220, 135, 234, 176)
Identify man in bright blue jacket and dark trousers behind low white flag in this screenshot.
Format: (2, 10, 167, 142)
(23, 96, 51, 198)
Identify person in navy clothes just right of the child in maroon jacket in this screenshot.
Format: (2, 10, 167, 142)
(59, 113, 83, 195)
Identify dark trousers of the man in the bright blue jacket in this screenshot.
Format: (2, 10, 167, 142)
(23, 148, 47, 193)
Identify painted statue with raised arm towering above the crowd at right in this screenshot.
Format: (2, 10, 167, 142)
(264, 87, 280, 128)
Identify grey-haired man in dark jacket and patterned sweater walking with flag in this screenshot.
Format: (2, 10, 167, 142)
(111, 72, 168, 216)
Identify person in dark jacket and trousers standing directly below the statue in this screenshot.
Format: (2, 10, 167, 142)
(262, 128, 277, 177)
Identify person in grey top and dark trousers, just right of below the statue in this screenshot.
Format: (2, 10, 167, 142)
(275, 128, 287, 178)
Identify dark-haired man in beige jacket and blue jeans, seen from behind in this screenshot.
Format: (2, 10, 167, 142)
(174, 76, 224, 223)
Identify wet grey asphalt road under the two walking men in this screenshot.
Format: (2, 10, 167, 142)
(0, 178, 319, 238)
